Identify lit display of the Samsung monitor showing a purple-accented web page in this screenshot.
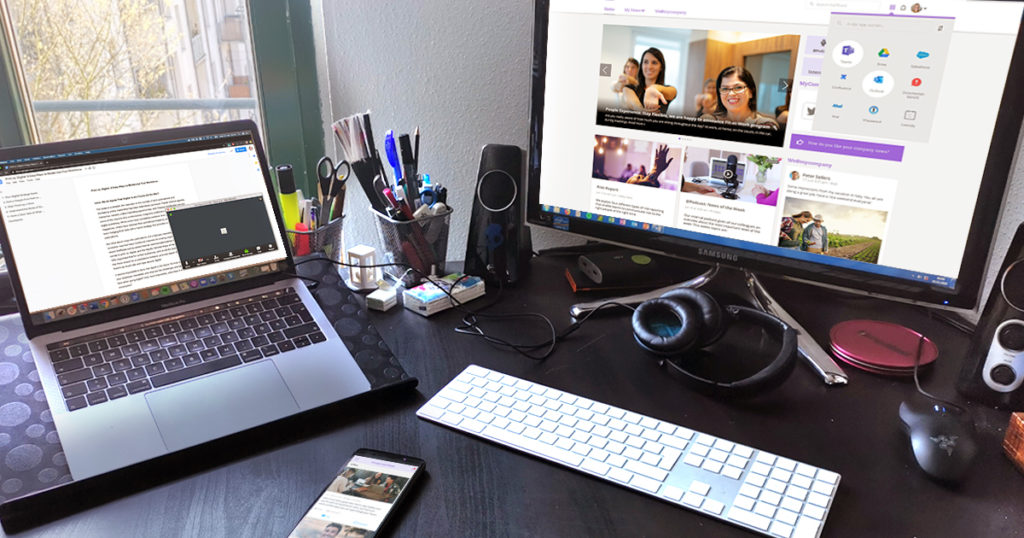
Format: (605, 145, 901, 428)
(540, 0, 1021, 288)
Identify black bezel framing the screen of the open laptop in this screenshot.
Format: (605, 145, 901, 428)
(0, 120, 295, 338)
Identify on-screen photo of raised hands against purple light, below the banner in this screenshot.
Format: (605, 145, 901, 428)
(593, 135, 683, 191)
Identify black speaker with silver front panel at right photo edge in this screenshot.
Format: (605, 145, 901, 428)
(956, 219, 1024, 411)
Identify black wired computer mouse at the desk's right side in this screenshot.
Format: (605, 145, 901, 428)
(899, 402, 978, 483)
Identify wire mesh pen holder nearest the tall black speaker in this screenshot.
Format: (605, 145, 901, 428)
(374, 205, 452, 288)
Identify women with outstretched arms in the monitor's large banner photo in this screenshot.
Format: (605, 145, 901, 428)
(611, 47, 779, 129)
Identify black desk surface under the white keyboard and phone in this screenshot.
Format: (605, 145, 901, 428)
(2, 257, 1024, 537)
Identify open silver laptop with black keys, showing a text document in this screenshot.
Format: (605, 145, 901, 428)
(0, 121, 370, 480)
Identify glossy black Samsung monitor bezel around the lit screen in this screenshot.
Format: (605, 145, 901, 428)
(526, 0, 1024, 309)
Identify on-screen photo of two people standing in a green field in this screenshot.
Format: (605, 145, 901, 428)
(778, 198, 889, 263)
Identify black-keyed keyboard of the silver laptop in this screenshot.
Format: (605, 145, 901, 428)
(46, 288, 327, 411)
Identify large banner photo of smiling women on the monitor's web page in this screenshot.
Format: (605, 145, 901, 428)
(597, 25, 800, 147)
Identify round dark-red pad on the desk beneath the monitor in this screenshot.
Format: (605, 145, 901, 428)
(828, 320, 939, 375)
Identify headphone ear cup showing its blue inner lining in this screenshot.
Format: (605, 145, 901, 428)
(633, 297, 701, 356)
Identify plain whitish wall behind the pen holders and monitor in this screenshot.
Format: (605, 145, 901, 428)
(312, 0, 1024, 319)
